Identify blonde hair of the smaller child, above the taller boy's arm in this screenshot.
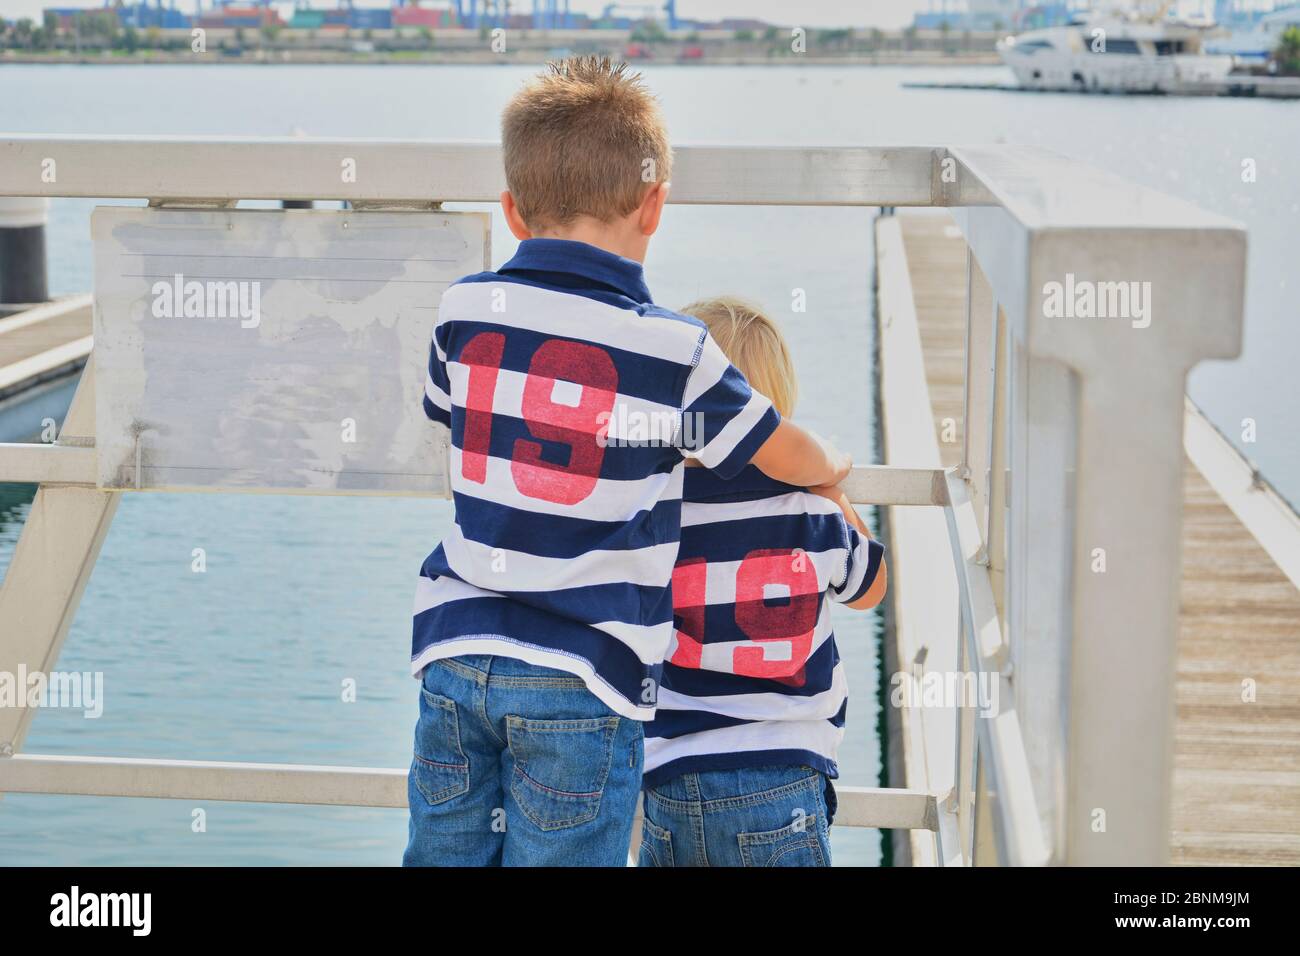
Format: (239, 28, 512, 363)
(681, 297, 800, 418)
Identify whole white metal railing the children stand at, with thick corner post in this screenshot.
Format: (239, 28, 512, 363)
(0, 135, 1245, 864)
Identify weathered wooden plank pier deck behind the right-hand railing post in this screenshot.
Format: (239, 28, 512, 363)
(878, 212, 1300, 865)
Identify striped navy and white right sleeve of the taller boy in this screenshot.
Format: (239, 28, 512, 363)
(681, 333, 781, 479)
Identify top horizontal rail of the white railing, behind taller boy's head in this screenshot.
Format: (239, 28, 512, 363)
(0, 133, 1240, 231)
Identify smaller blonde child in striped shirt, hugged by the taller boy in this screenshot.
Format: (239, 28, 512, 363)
(640, 298, 885, 866)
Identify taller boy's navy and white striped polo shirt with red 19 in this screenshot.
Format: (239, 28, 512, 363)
(411, 239, 780, 719)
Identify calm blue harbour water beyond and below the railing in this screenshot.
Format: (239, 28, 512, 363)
(0, 66, 1300, 864)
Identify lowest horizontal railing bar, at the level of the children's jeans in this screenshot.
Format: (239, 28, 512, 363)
(0, 753, 936, 830)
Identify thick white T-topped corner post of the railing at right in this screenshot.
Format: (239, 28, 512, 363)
(952, 147, 1245, 865)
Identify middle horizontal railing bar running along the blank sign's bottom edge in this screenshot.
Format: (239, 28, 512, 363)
(0, 442, 946, 505)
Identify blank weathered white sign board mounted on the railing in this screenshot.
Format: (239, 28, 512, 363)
(91, 207, 490, 494)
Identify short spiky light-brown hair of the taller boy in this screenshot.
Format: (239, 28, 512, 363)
(501, 56, 672, 232)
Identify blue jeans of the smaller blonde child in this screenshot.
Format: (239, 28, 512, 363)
(640, 766, 835, 866)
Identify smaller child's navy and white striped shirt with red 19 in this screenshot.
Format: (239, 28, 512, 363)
(645, 466, 884, 787)
